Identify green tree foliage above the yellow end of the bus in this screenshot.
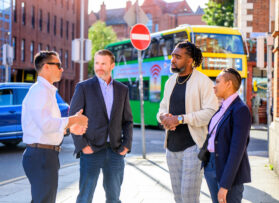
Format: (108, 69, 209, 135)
(202, 0, 234, 27)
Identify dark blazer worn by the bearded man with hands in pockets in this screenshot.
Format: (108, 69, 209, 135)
(69, 76, 133, 153)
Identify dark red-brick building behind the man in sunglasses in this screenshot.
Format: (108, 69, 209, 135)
(11, 0, 88, 102)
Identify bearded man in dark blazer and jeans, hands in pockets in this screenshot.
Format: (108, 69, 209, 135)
(70, 50, 133, 203)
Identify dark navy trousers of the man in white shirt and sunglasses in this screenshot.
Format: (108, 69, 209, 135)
(22, 147, 60, 203)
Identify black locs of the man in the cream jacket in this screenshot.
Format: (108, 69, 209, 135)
(175, 41, 203, 67)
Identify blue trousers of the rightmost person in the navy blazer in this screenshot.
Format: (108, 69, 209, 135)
(204, 153, 244, 203)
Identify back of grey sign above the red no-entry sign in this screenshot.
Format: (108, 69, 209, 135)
(124, 2, 148, 26)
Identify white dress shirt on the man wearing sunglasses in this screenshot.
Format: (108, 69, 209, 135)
(21, 76, 69, 145)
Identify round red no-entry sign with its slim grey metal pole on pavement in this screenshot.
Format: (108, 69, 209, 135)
(130, 24, 151, 159)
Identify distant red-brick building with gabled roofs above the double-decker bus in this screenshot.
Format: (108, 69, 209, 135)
(89, 0, 206, 39)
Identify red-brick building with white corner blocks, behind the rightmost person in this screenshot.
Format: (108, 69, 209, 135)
(235, 0, 275, 123)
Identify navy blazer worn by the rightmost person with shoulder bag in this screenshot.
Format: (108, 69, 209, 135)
(210, 97, 251, 189)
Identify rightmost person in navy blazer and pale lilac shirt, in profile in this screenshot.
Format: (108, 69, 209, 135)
(204, 68, 251, 203)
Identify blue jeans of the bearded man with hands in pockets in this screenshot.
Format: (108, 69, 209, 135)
(77, 147, 124, 203)
